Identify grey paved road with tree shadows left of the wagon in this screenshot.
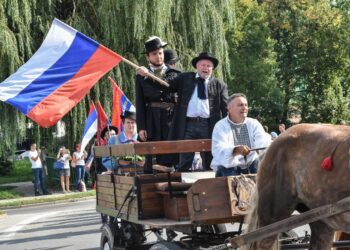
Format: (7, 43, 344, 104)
(0, 199, 101, 250)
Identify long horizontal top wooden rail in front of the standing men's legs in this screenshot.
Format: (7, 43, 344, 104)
(94, 139, 211, 157)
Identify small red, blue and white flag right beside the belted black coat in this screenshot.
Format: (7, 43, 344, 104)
(108, 77, 136, 131)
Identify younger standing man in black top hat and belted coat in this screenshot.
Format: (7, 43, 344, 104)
(136, 36, 181, 173)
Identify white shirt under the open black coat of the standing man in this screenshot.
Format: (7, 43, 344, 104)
(186, 73, 210, 118)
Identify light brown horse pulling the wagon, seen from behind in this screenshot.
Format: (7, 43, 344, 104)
(246, 124, 350, 250)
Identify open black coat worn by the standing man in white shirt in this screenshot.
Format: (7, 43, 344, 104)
(169, 72, 228, 140)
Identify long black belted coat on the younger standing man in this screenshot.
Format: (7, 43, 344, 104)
(135, 68, 181, 141)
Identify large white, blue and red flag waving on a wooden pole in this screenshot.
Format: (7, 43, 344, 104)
(0, 19, 122, 127)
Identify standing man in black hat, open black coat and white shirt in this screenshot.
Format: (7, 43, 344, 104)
(169, 52, 228, 171)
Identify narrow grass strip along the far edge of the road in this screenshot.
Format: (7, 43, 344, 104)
(0, 190, 96, 209)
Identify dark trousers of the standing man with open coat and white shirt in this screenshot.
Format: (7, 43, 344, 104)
(179, 118, 213, 172)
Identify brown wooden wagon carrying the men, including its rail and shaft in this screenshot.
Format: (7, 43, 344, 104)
(94, 140, 350, 249)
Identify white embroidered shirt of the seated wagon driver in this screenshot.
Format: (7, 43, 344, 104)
(210, 116, 271, 171)
